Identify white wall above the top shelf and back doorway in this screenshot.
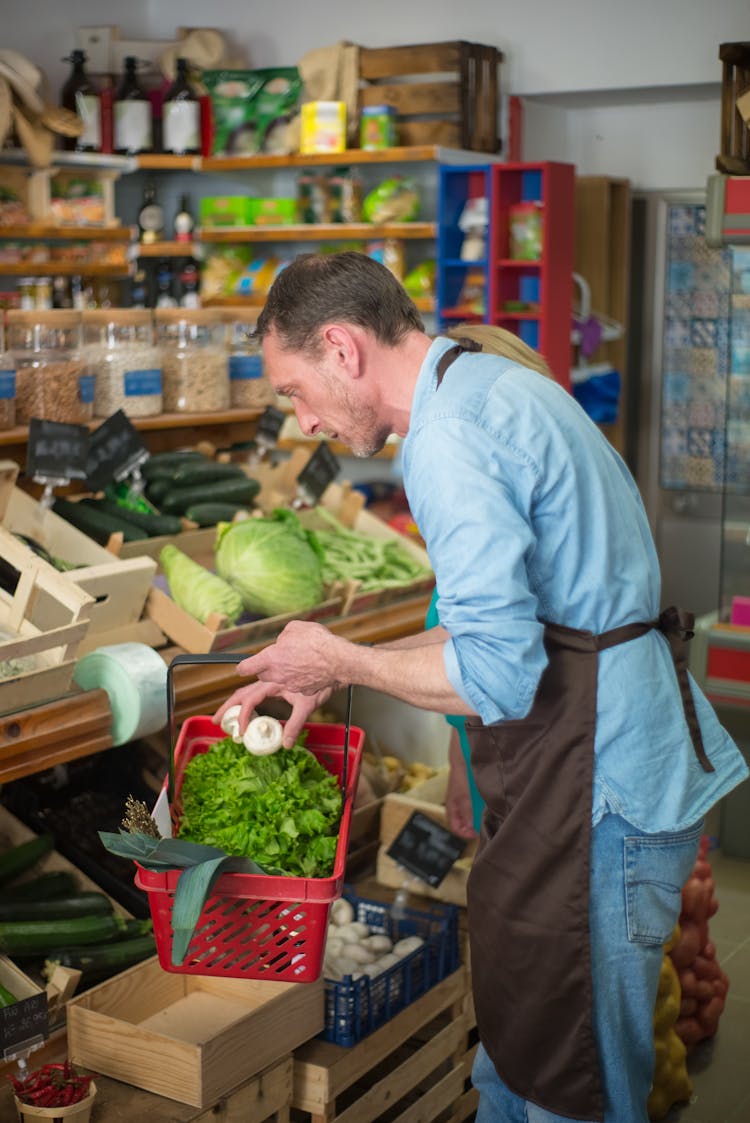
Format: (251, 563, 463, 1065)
(1, 0, 748, 189)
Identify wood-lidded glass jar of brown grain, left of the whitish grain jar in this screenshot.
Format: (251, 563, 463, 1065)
(7, 309, 94, 424)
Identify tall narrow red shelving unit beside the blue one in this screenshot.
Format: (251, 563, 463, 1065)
(487, 162, 576, 390)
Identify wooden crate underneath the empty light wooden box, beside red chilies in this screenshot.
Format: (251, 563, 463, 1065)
(0, 1056, 292, 1123)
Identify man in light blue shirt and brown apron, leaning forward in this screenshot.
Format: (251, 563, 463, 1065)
(217, 253, 747, 1123)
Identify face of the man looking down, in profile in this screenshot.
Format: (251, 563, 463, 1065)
(263, 331, 390, 457)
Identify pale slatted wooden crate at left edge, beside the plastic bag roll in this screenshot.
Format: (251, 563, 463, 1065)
(0, 527, 94, 713)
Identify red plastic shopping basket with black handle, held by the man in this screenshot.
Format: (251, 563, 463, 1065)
(135, 654, 365, 983)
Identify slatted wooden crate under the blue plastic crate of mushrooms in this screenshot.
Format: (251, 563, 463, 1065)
(292, 967, 469, 1123)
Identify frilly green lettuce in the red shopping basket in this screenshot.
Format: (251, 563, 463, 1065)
(177, 738, 341, 877)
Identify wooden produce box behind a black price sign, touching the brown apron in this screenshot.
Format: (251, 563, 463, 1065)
(376, 768, 477, 905)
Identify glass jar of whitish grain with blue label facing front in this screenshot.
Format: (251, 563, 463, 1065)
(81, 308, 162, 418)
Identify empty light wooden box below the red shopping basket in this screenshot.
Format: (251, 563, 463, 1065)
(67, 957, 324, 1107)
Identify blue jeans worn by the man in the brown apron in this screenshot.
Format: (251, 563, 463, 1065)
(472, 815, 703, 1123)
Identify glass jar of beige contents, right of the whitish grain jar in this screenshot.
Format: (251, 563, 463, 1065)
(154, 308, 229, 413)
